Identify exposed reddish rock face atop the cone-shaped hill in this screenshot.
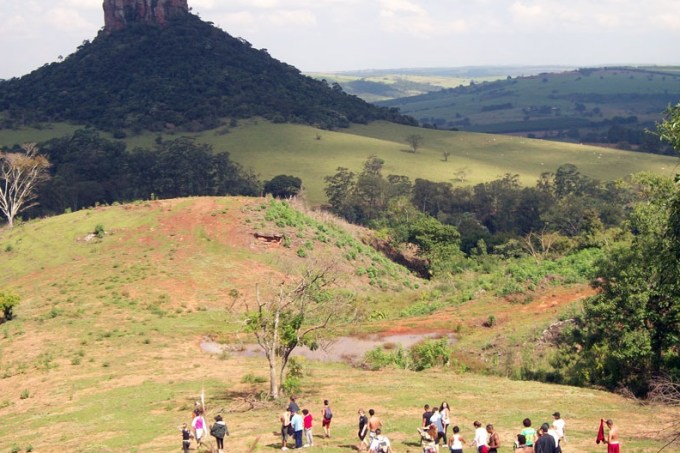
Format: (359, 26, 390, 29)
(104, 0, 189, 32)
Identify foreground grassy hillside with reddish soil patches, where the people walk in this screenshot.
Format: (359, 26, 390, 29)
(0, 198, 680, 453)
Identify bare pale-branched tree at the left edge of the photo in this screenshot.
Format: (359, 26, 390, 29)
(0, 143, 50, 228)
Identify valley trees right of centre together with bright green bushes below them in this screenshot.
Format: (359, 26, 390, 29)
(326, 156, 639, 274)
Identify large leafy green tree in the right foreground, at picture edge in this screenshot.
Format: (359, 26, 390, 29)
(555, 107, 680, 394)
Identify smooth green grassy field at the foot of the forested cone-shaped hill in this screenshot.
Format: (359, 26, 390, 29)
(0, 120, 677, 205)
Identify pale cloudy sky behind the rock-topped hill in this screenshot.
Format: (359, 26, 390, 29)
(0, 0, 680, 79)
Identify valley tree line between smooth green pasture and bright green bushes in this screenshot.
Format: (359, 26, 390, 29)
(325, 156, 636, 255)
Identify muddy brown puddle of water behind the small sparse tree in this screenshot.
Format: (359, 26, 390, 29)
(201, 334, 455, 363)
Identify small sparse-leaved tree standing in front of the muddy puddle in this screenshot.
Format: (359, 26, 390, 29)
(246, 265, 344, 399)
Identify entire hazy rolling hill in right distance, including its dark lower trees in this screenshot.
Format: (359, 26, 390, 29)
(379, 67, 680, 149)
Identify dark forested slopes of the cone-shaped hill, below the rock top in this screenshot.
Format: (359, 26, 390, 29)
(0, 15, 415, 135)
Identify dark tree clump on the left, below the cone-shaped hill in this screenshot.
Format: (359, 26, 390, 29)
(29, 129, 261, 216)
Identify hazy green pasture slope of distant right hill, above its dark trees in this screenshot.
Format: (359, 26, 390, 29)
(384, 68, 680, 130)
